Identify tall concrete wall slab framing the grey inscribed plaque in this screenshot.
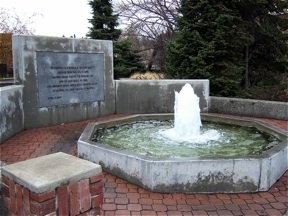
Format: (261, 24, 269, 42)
(13, 35, 115, 128)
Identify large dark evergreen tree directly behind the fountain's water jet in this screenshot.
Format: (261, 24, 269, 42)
(167, 0, 246, 96)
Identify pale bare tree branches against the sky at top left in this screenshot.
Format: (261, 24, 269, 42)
(0, 8, 36, 35)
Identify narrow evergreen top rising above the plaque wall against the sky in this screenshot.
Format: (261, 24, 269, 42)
(87, 0, 121, 40)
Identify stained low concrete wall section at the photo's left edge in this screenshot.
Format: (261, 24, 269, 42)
(0, 85, 24, 143)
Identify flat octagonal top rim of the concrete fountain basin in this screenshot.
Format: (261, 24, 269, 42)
(79, 113, 288, 162)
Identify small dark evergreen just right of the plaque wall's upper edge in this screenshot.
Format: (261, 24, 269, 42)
(114, 39, 144, 79)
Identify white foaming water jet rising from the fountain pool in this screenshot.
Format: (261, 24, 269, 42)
(160, 83, 220, 143)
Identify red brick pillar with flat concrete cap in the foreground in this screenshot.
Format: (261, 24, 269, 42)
(1, 152, 103, 216)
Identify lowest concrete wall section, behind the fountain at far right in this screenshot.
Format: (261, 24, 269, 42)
(209, 97, 288, 120)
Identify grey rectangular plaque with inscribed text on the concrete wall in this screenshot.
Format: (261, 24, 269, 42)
(36, 52, 104, 107)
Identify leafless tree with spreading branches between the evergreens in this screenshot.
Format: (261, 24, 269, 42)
(116, 0, 180, 71)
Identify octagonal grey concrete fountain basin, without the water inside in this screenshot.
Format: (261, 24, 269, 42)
(78, 113, 288, 193)
